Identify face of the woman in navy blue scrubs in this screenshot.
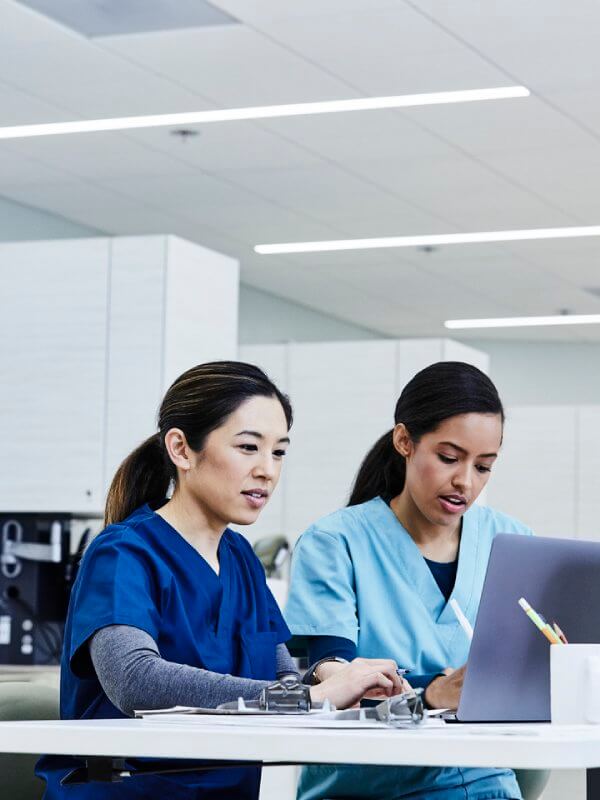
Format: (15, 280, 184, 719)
(179, 397, 290, 526)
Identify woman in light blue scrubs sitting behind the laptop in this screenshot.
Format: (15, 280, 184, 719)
(285, 362, 531, 800)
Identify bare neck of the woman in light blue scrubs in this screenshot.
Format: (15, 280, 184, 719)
(390, 491, 462, 562)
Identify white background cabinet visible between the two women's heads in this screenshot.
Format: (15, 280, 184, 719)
(240, 339, 487, 542)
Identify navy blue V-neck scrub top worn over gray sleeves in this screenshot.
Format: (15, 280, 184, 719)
(37, 505, 290, 800)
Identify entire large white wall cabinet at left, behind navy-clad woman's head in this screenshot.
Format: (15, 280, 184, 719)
(0, 236, 238, 515)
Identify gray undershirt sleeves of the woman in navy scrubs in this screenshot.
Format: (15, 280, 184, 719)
(89, 625, 297, 716)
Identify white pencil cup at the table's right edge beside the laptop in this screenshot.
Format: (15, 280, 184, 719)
(550, 644, 600, 725)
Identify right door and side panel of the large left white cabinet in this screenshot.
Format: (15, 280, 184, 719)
(103, 236, 239, 487)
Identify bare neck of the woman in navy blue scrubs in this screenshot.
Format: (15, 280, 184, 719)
(156, 491, 226, 574)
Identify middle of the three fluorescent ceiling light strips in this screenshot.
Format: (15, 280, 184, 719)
(254, 225, 600, 255)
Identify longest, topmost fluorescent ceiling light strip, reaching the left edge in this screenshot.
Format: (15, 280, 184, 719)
(0, 86, 530, 139)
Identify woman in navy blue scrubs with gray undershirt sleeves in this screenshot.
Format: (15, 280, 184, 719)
(37, 362, 402, 800)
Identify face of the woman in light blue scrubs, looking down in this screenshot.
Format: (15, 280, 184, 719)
(394, 414, 502, 526)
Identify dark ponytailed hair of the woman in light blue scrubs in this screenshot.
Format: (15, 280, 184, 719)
(348, 361, 504, 506)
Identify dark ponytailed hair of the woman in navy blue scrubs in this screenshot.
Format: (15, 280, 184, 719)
(104, 361, 292, 525)
